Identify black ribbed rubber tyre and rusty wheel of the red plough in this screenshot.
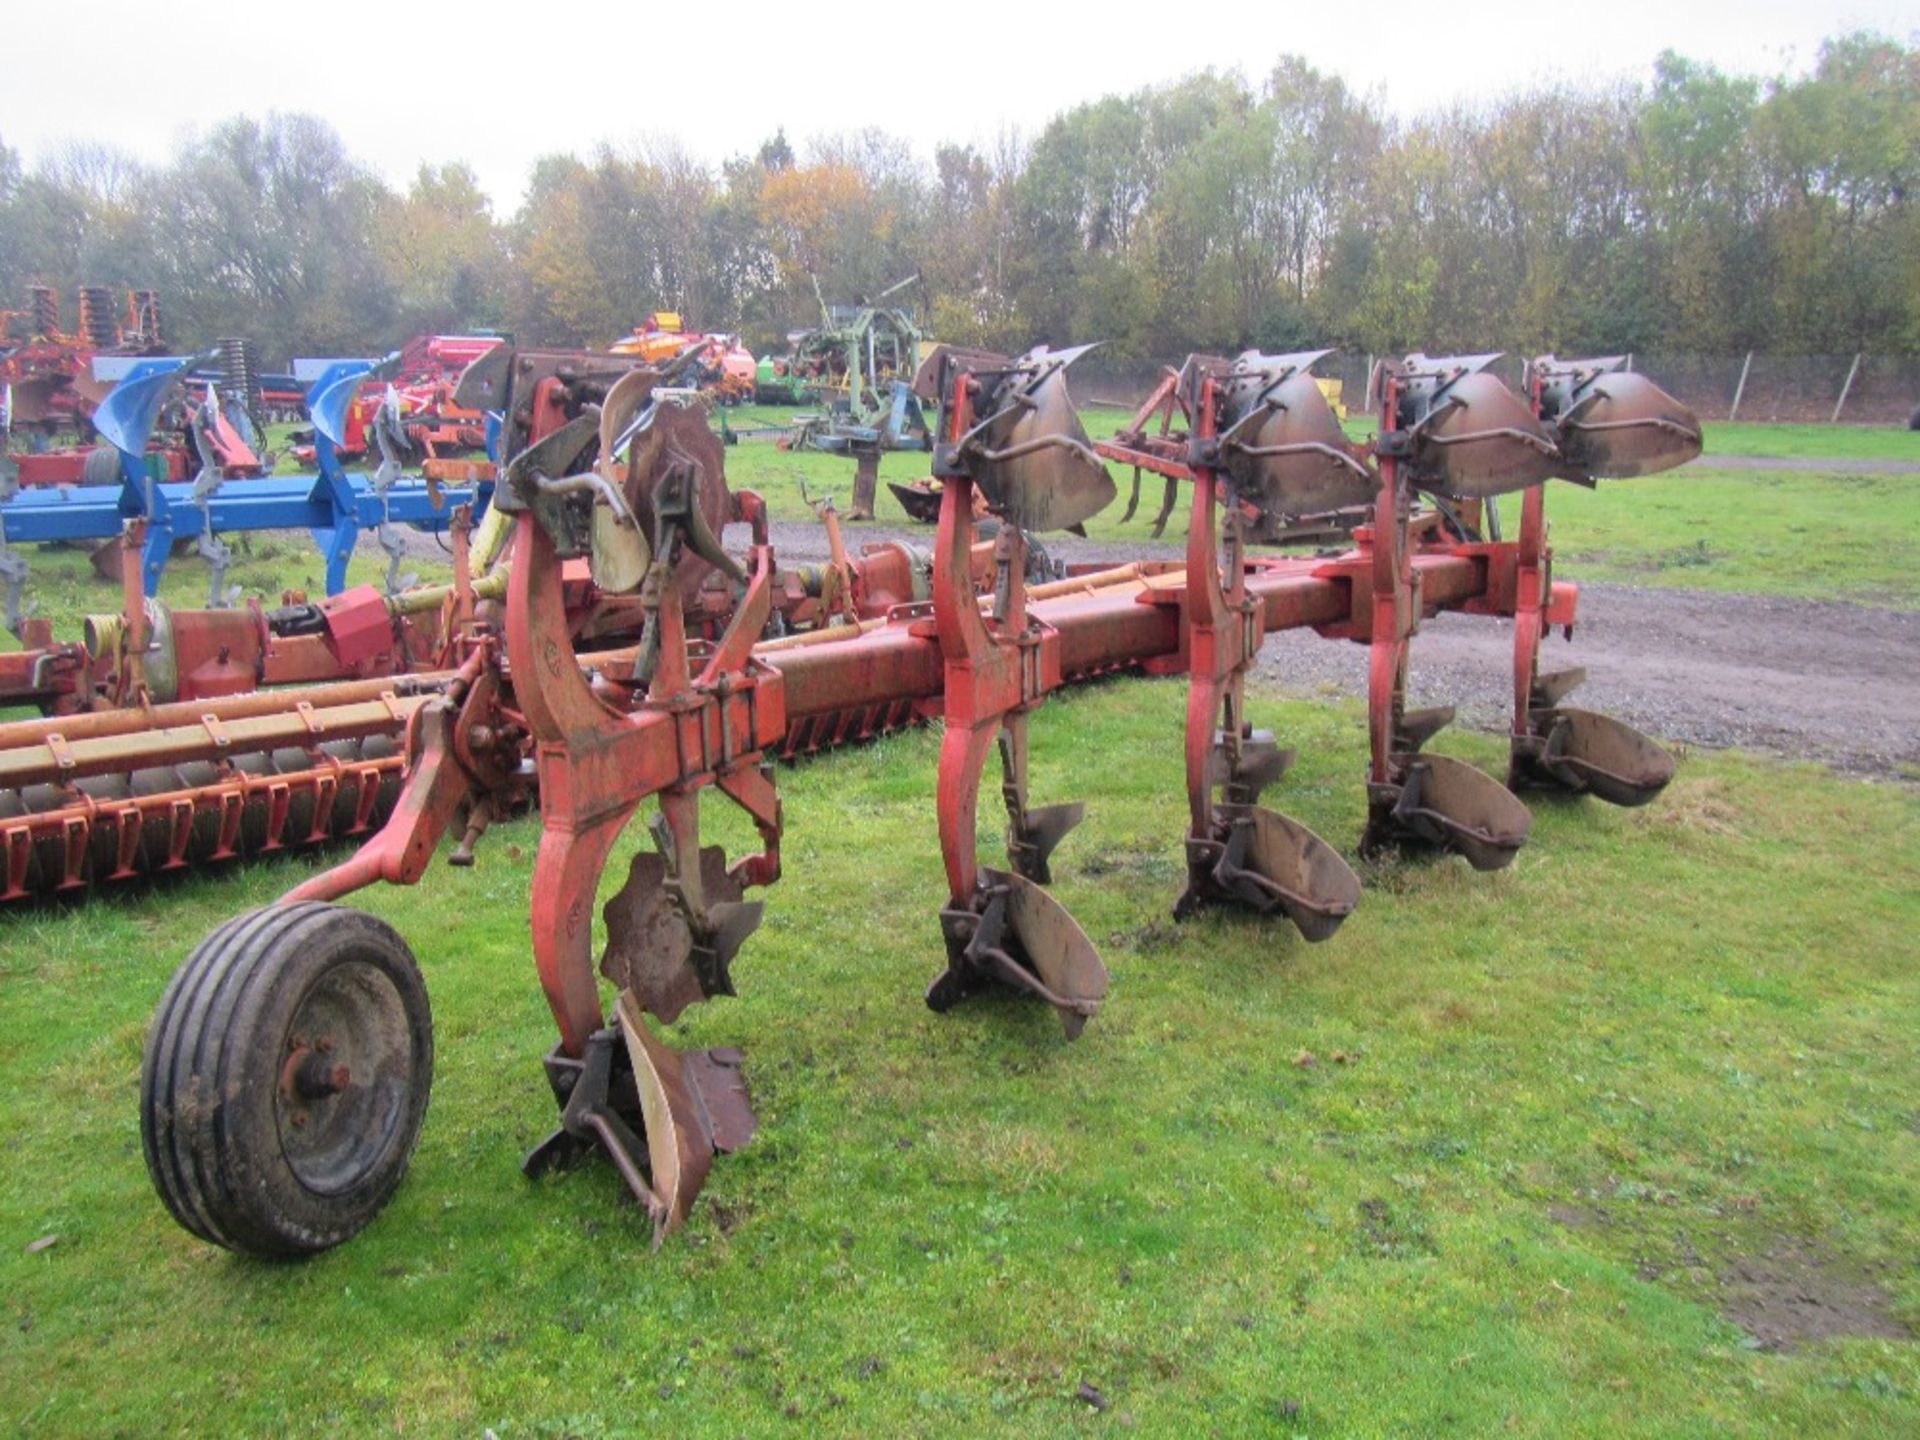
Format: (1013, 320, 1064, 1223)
(140, 902, 434, 1260)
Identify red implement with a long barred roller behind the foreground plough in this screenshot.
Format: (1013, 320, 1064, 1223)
(0, 462, 975, 900)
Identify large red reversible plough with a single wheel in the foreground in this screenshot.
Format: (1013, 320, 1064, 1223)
(142, 348, 1699, 1256)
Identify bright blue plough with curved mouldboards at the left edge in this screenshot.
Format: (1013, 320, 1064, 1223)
(0, 357, 493, 630)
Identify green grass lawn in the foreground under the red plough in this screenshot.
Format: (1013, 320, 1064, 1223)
(0, 682, 1920, 1440)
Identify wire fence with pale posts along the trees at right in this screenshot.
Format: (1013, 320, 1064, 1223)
(1073, 351, 1920, 424)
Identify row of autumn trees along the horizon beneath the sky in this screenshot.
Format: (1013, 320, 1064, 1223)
(0, 35, 1920, 363)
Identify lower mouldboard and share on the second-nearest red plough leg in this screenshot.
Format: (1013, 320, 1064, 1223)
(927, 870, 1108, 1039)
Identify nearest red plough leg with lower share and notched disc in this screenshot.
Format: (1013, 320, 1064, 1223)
(509, 432, 785, 1242)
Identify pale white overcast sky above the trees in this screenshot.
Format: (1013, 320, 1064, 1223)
(0, 0, 1920, 213)
